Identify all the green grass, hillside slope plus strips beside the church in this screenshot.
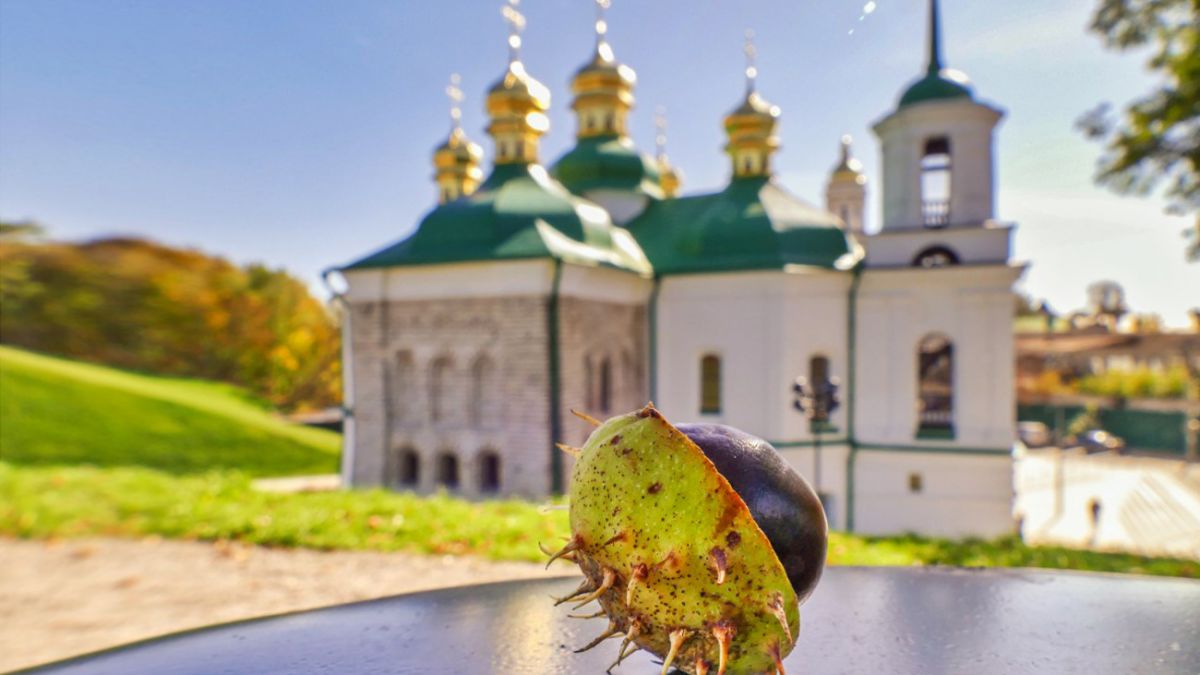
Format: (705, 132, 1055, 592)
(0, 347, 1200, 578)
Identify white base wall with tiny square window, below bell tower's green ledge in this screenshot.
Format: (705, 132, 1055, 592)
(854, 449, 1015, 537)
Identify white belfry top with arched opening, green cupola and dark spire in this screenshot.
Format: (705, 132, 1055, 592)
(874, 0, 1004, 232)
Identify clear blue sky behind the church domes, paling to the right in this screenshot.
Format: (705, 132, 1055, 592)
(0, 0, 1200, 325)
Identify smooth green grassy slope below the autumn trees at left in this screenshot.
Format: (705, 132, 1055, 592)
(0, 347, 340, 476)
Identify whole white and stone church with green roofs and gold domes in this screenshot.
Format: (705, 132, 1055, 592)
(337, 0, 1024, 536)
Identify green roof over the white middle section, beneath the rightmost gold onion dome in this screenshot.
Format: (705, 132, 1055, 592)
(629, 178, 862, 274)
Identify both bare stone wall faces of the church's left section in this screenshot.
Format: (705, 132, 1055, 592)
(350, 295, 647, 497)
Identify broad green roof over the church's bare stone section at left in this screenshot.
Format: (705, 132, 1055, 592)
(342, 165, 650, 274)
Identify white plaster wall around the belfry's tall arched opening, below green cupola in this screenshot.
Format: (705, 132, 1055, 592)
(874, 98, 1003, 229)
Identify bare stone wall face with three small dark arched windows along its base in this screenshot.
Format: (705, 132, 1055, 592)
(352, 295, 551, 497)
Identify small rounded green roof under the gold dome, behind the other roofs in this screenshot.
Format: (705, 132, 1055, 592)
(551, 135, 662, 199)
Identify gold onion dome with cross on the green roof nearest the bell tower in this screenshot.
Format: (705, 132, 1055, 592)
(725, 30, 780, 178)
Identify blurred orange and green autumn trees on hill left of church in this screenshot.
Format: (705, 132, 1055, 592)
(0, 230, 341, 408)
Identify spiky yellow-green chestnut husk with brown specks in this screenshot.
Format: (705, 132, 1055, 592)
(549, 406, 799, 675)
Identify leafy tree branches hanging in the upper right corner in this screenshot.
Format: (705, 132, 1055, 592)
(1078, 0, 1200, 262)
